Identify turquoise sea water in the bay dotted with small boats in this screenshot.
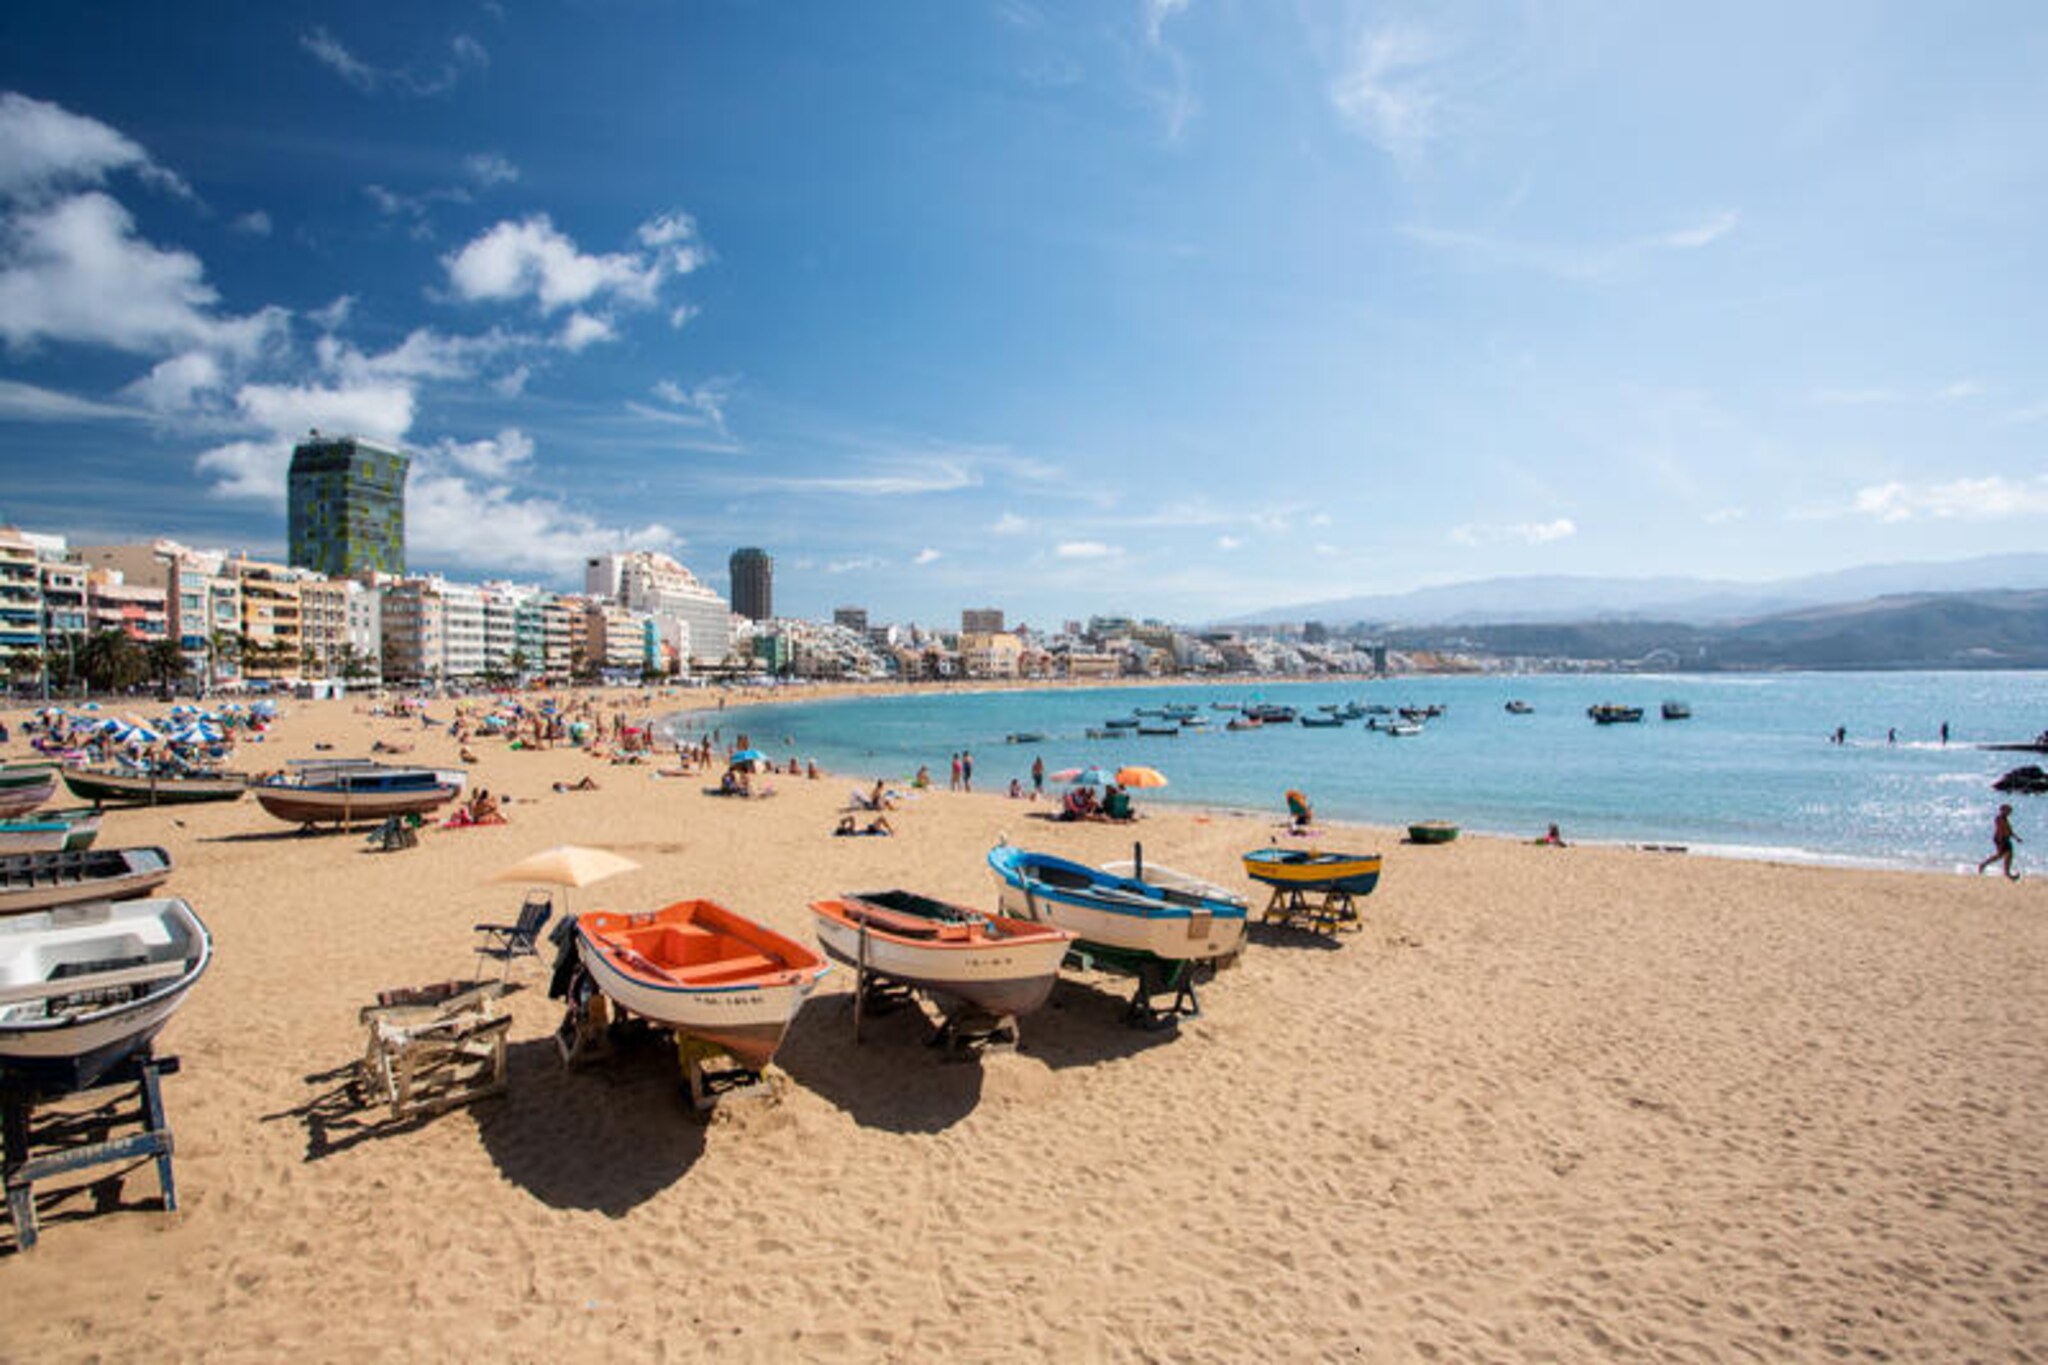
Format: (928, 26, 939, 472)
(663, 673, 2048, 868)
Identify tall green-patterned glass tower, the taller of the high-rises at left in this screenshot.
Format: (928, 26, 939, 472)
(287, 432, 412, 579)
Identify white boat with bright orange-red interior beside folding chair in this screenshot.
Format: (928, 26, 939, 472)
(575, 900, 831, 1072)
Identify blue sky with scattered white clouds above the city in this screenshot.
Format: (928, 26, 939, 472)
(0, 0, 2048, 624)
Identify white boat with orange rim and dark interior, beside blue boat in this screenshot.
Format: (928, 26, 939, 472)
(811, 890, 1073, 1017)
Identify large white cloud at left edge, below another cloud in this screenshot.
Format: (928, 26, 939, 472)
(0, 190, 287, 358)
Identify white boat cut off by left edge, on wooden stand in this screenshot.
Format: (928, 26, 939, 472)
(0, 896, 213, 1091)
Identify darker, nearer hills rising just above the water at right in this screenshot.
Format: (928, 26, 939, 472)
(1382, 589, 2048, 671)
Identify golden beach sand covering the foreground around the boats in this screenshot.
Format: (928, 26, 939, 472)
(0, 702, 2048, 1361)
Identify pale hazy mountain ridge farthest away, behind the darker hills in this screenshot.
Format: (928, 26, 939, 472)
(1219, 555, 2048, 628)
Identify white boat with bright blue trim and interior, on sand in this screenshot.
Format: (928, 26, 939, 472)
(989, 843, 1245, 962)
